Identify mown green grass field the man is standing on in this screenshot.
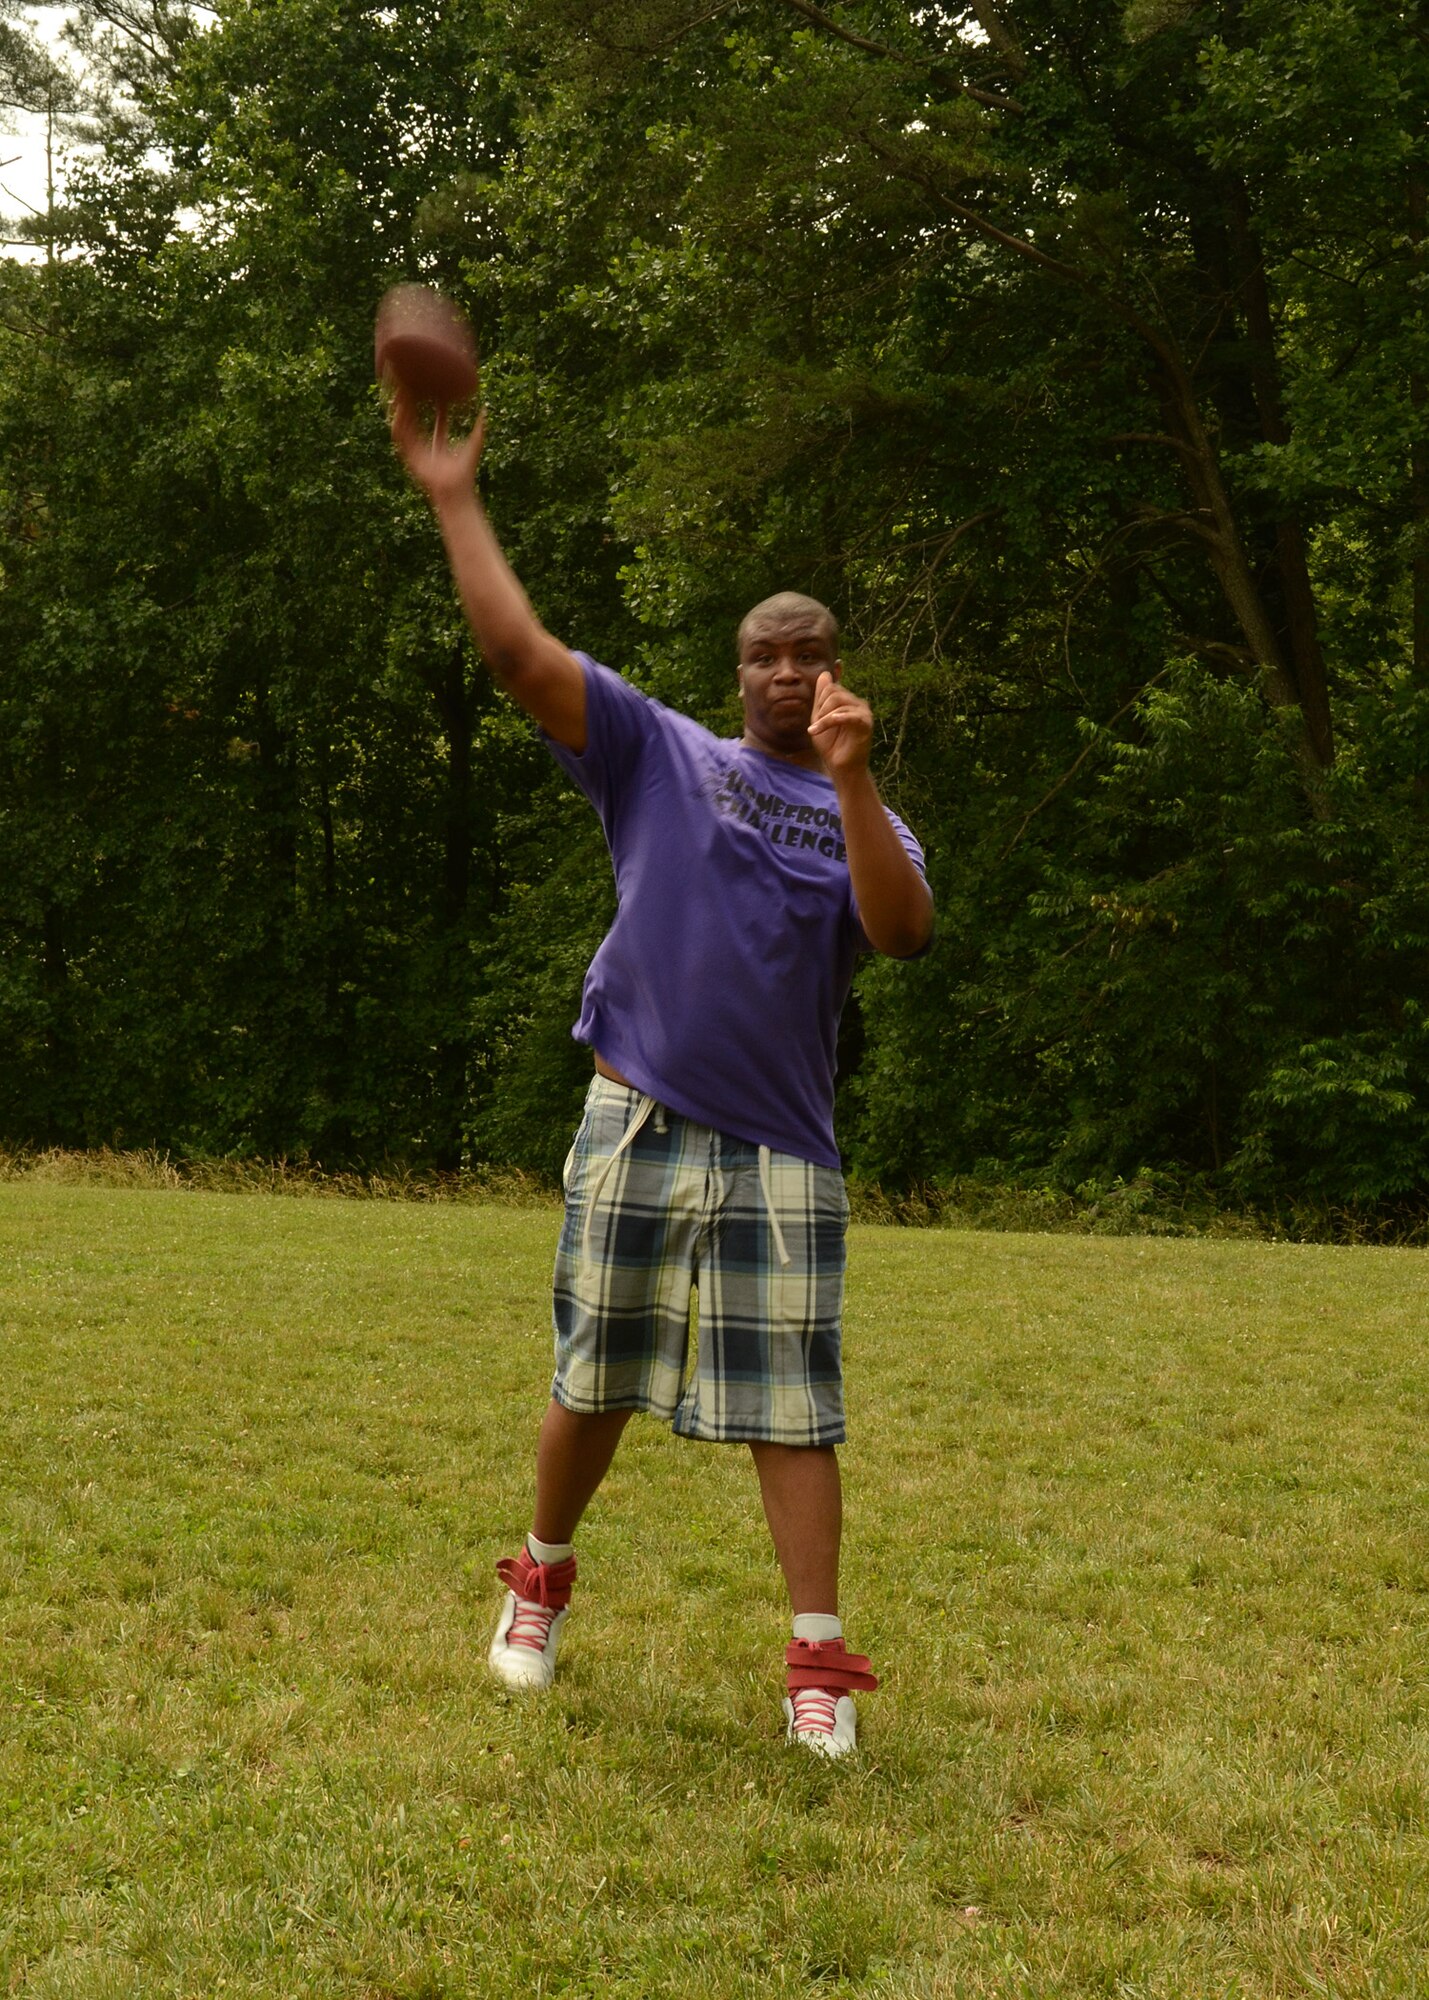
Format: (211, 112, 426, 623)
(0, 1182, 1429, 2000)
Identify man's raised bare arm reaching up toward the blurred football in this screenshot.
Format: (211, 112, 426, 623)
(392, 390, 586, 756)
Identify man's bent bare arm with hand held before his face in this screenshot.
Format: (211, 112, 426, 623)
(809, 674, 933, 958)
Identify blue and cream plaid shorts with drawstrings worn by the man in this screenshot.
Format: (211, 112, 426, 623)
(552, 1076, 849, 1444)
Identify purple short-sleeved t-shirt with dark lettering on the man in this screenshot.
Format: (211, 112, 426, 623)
(546, 654, 923, 1166)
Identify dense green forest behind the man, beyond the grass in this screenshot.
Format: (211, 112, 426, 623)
(0, 0, 1429, 1216)
